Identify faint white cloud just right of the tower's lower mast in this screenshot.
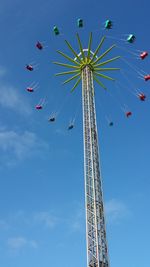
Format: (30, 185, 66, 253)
(105, 199, 130, 223)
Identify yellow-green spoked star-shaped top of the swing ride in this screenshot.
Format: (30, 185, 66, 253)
(54, 33, 120, 91)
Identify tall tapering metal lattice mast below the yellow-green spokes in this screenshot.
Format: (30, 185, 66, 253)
(82, 66, 109, 267)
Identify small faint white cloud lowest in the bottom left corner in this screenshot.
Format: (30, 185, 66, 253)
(7, 236, 38, 251)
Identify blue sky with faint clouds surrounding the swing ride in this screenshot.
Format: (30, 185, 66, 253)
(0, 0, 150, 267)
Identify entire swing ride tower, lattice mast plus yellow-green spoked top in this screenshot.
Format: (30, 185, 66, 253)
(54, 33, 119, 267)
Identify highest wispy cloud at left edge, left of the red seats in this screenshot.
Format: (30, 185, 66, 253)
(0, 84, 32, 115)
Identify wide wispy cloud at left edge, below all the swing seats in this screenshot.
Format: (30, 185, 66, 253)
(0, 130, 48, 165)
